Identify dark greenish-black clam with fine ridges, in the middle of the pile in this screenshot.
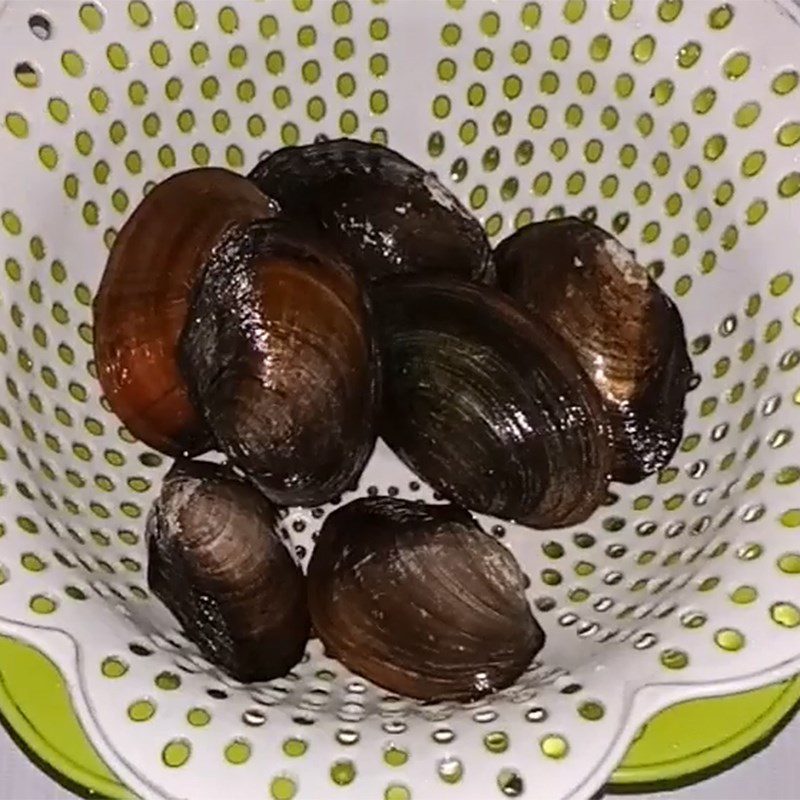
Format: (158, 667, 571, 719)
(373, 276, 611, 528)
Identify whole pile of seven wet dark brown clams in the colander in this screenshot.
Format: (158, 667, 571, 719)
(94, 139, 692, 702)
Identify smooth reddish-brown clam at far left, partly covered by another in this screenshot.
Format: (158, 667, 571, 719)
(94, 167, 275, 456)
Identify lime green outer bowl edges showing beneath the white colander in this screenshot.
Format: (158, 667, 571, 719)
(0, 636, 800, 800)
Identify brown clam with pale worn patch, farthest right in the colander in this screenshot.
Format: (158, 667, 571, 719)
(496, 218, 692, 483)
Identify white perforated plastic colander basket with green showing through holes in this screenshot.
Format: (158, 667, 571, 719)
(0, 0, 800, 800)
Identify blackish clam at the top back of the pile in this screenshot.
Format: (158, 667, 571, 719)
(250, 139, 494, 282)
